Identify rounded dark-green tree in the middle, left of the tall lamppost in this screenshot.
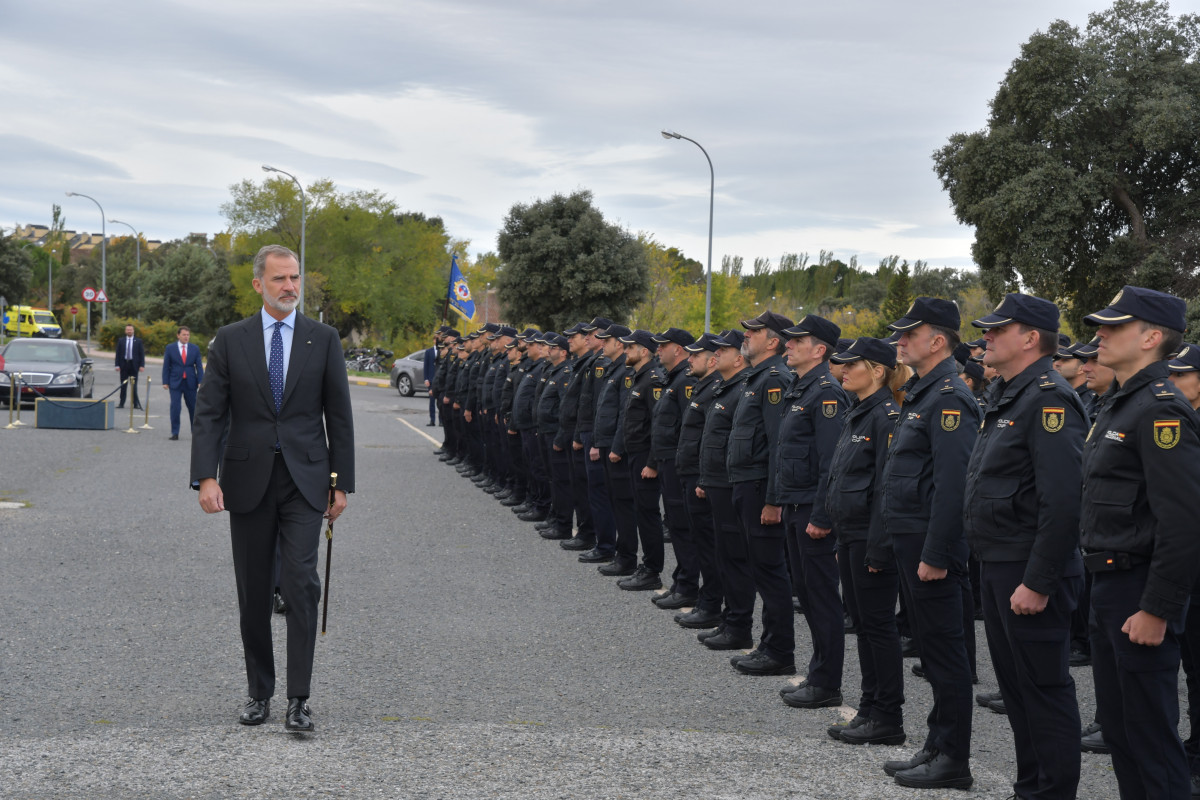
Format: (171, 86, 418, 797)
(497, 191, 649, 330)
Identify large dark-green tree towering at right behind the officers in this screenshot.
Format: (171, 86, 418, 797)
(934, 0, 1200, 330)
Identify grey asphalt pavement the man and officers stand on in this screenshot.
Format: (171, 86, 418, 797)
(0, 371, 1117, 799)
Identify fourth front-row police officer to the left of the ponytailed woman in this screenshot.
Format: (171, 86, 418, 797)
(671, 333, 725, 628)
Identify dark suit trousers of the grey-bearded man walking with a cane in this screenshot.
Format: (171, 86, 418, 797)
(229, 455, 324, 699)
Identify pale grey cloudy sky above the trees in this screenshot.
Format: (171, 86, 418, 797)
(0, 0, 1118, 267)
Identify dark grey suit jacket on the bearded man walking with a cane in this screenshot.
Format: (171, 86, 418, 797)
(192, 313, 354, 513)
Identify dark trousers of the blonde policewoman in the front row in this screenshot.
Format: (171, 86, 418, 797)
(838, 541, 904, 726)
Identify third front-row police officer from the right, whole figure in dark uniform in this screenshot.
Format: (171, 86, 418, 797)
(881, 297, 980, 788)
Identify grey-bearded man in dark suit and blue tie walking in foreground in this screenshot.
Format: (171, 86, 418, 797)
(192, 245, 354, 730)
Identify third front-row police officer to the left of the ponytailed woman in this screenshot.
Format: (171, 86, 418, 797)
(696, 330, 754, 650)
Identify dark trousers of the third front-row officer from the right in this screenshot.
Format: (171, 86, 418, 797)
(892, 534, 972, 760)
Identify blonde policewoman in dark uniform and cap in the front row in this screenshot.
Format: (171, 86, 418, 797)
(830, 337, 907, 745)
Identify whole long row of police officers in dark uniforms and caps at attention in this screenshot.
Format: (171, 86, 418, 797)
(431, 287, 1200, 800)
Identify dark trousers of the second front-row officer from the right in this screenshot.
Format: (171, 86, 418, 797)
(979, 557, 1084, 800)
